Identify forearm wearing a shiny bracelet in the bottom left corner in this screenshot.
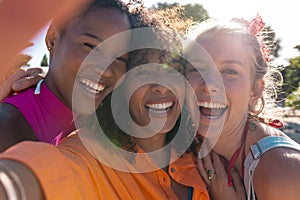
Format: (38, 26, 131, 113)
(0, 160, 45, 200)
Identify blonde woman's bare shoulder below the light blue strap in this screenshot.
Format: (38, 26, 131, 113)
(254, 148, 300, 200)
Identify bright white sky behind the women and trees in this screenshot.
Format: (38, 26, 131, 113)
(25, 0, 300, 66)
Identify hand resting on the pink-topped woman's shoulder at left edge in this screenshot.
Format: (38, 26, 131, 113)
(0, 67, 48, 101)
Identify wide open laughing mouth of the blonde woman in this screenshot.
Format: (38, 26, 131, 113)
(198, 101, 227, 119)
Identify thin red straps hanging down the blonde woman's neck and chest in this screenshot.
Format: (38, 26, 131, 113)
(227, 119, 249, 187)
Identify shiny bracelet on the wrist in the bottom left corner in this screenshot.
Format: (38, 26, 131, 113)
(0, 162, 26, 200)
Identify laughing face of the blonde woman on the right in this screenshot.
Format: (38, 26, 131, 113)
(186, 35, 257, 135)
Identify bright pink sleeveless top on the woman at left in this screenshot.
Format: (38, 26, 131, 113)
(4, 81, 75, 145)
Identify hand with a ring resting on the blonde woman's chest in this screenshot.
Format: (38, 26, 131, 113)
(198, 152, 246, 200)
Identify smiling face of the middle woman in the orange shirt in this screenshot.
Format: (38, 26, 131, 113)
(124, 51, 185, 133)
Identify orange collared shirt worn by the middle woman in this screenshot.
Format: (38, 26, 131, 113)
(0, 131, 209, 200)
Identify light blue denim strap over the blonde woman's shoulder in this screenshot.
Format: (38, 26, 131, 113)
(250, 136, 300, 160)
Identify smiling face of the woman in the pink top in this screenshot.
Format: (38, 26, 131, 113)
(45, 7, 130, 114)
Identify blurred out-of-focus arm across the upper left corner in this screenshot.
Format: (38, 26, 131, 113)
(0, 0, 89, 78)
